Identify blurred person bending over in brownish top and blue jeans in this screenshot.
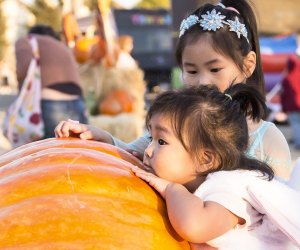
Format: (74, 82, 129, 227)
(15, 25, 87, 138)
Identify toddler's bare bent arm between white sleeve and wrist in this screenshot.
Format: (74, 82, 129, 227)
(165, 183, 242, 243)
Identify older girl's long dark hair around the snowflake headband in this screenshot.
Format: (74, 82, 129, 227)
(175, 0, 265, 98)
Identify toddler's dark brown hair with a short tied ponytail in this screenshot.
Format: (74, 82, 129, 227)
(146, 83, 274, 180)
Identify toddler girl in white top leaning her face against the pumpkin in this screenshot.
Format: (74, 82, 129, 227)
(132, 84, 300, 250)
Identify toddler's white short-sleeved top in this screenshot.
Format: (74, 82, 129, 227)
(194, 170, 300, 250)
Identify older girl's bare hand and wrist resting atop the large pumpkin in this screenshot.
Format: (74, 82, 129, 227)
(54, 119, 113, 144)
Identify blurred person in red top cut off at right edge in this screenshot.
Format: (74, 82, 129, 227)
(281, 47, 300, 150)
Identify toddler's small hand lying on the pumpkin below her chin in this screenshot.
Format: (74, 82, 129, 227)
(131, 166, 171, 198)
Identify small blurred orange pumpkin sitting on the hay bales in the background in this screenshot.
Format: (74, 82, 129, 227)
(99, 89, 133, 115)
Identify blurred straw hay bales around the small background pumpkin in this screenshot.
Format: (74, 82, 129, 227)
(81, 65, 146, 142)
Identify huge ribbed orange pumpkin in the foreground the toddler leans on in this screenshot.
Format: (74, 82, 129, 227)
(0, 139, 189, 250)
